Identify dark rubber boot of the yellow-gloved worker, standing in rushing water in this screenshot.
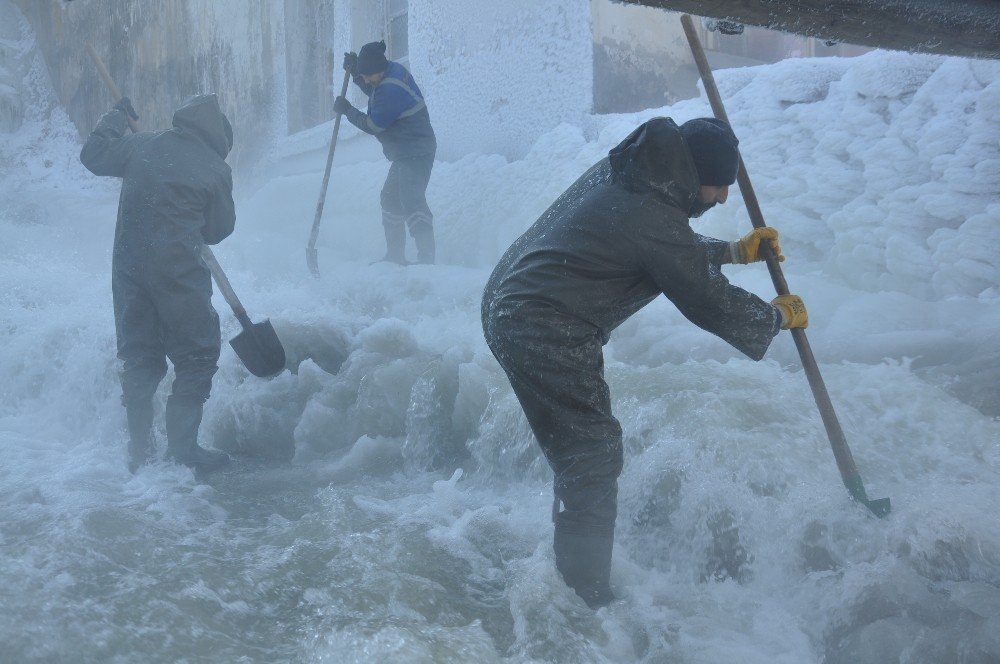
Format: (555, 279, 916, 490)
(552, 512, 615, 609)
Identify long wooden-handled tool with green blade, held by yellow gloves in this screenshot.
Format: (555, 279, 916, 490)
(681, 14, 891, 517)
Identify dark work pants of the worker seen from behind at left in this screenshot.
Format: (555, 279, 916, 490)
(112, 259, 222, 408)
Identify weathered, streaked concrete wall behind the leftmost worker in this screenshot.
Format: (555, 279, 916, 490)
(13, 0, 285, 165)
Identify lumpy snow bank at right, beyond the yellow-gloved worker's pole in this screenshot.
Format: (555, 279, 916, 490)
(723, 54, 1000, 299)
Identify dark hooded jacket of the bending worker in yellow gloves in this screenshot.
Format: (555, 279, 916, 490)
(483, 118, 779, 360)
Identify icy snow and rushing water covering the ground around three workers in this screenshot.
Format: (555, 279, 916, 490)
(0, 28, 1000, 664)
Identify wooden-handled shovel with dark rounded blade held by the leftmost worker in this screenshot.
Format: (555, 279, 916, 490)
(87, 44, 285, 378)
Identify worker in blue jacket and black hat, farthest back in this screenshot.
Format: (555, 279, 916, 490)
(333, 42, 437, 265)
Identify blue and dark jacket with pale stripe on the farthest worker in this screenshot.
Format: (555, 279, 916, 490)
(345, 62, 437, 161)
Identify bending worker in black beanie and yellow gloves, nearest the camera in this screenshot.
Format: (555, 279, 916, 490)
(482, 118, 807, 607)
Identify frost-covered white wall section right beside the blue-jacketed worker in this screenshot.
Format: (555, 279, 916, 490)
(409, 0, 593, 159)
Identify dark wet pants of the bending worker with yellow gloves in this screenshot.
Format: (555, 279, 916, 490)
(484, 316, 622, 536)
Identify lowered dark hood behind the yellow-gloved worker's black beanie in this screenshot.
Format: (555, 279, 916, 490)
(608, 118, 699, 212)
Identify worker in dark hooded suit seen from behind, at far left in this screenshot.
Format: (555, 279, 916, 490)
(80, 94, 236, 472)
